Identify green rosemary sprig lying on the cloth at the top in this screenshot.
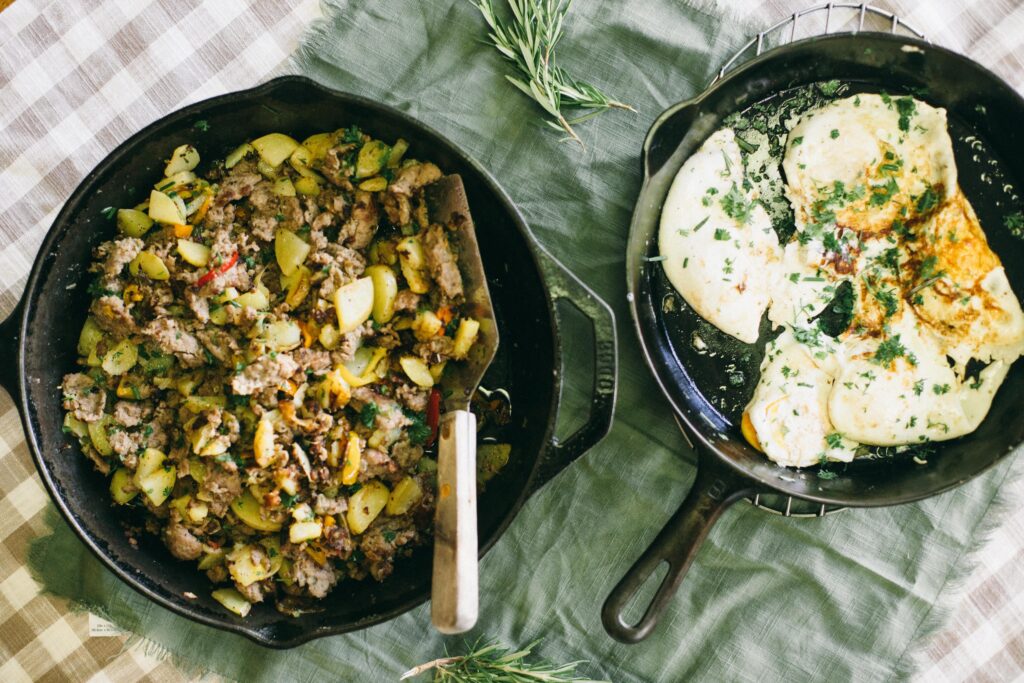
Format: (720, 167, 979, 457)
(470, 0, 636, 145)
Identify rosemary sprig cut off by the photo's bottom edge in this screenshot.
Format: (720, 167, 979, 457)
(399, 640, 607, 683)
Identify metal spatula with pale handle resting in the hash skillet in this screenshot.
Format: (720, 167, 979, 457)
(427, 175, 498, 633)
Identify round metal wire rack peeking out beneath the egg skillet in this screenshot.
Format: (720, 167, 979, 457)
(704, 2, 927, 517)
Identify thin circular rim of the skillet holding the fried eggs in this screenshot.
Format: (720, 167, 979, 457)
(626, 31, 1024, 508)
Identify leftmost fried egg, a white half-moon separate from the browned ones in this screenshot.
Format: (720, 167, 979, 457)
(658, 128, 780, 344)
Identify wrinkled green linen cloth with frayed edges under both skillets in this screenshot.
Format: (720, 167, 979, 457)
(32, 0, 1010, 681)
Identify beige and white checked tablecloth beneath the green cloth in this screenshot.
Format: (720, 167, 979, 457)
(0, 0, 1024, 682)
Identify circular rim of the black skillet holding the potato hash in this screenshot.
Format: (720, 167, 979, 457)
(12, 74, 571, 649)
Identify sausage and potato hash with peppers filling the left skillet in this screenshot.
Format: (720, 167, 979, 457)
(56, 127, 509, 616)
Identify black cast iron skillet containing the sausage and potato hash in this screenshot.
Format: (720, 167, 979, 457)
(0, 77, 616, 647)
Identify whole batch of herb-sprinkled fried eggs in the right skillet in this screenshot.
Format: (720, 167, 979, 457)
(656, 81, 1024, 467)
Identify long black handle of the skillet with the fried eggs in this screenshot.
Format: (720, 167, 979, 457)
(601, 446, 754, 644)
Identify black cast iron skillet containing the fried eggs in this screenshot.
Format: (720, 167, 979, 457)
(602, 34, 1024, 643)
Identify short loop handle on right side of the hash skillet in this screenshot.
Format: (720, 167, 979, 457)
(528, 245, 618, 494)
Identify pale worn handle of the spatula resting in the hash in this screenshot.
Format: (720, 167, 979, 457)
(430, 411, 479, 633)
